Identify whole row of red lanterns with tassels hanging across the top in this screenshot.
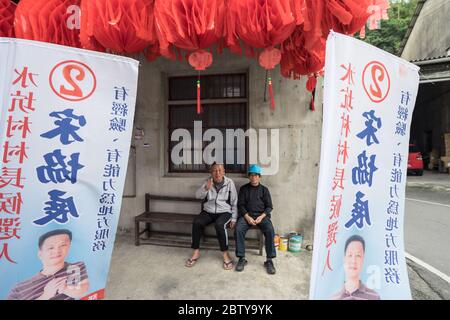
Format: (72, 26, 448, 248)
(4, 0, 376, 112)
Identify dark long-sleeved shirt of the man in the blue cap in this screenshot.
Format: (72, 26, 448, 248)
(238, 183, 273, 218)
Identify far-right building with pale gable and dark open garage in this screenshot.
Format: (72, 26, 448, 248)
(401, 0, 450, 161)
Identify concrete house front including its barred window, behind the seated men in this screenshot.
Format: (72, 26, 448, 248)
(119, 51, 322, 243)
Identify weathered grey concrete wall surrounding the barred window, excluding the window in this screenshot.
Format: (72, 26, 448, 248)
(119, 52, 322, 241)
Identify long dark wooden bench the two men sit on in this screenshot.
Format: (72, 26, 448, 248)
(134, 193, 264, 255)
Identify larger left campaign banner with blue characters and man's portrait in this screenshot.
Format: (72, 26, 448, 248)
(0, 38, 138, 300)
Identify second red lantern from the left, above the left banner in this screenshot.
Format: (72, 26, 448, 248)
(14, 0, 80, 47)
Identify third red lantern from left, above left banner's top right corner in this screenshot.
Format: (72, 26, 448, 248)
(80, 0, 157, 53)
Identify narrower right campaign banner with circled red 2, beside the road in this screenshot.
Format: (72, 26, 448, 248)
(310, 32, 419, 300)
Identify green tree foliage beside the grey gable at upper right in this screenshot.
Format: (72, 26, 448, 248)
(364, 0, 417, 54)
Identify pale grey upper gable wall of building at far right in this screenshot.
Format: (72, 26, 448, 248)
(402, 0, 450, 60)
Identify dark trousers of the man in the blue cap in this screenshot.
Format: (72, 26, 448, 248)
(235, 217, 277, 259)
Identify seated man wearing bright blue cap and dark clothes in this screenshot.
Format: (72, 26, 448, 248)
(235, 165, 276, 274)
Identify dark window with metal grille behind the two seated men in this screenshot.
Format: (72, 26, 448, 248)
(168, 74, 248, 173)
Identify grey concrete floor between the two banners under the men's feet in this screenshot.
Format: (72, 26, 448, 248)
(105, 234, 312, 300)
